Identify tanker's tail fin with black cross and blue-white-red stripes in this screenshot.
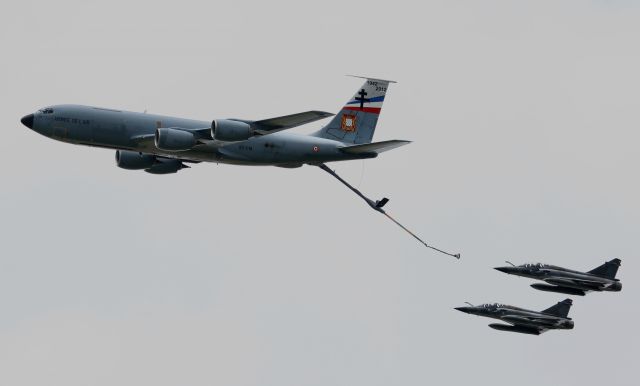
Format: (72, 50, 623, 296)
(314, 78, 395, 144)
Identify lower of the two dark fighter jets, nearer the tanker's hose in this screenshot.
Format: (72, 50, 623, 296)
(456, 299, 573, 335)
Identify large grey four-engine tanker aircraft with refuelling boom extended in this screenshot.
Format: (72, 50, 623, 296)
(21, 78, 460, 258)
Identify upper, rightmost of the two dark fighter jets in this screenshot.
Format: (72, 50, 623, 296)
(495, 259, 622, 296)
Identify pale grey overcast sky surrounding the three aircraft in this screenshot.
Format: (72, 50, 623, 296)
(0, 0, 640, 386)
